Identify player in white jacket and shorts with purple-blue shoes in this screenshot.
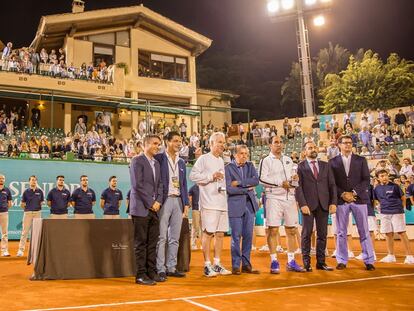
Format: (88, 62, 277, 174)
(259, 136, 305, 274)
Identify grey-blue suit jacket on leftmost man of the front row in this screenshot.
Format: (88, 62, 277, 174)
(129, 154, 163, 217)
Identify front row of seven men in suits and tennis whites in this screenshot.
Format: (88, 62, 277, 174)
(130, 132, 375, 285)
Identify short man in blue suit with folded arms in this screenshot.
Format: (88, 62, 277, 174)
(226, 145, 259, 275)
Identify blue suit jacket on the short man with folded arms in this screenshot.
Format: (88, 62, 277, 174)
(225, 162, 259, 217)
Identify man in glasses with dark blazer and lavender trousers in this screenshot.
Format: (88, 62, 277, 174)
(329, 135, 375, 271)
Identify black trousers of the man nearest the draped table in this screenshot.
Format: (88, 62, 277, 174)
(132, 211, 160, 278)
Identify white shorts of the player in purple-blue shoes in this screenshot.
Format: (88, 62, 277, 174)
(266, 197, 299, 227)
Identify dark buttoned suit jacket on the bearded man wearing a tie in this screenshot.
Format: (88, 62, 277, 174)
(295, 160, 337, 211)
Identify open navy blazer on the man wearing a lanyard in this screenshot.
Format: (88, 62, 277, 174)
(155, 152, 190, 208)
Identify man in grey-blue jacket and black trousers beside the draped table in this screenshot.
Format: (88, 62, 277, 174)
(129, 135, 163, 285)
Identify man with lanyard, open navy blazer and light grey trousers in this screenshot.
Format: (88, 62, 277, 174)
(155, 132, 189, 281)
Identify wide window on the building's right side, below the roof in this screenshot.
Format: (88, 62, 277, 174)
(138, 50, 188, 82)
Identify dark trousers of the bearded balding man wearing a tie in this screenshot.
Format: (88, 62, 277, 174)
(302, 206, 329, 266)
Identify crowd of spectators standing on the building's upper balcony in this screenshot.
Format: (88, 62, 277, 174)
(0, 42, 114, 83)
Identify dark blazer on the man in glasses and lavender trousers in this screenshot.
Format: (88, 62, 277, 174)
(329, 154, 370, 204)
